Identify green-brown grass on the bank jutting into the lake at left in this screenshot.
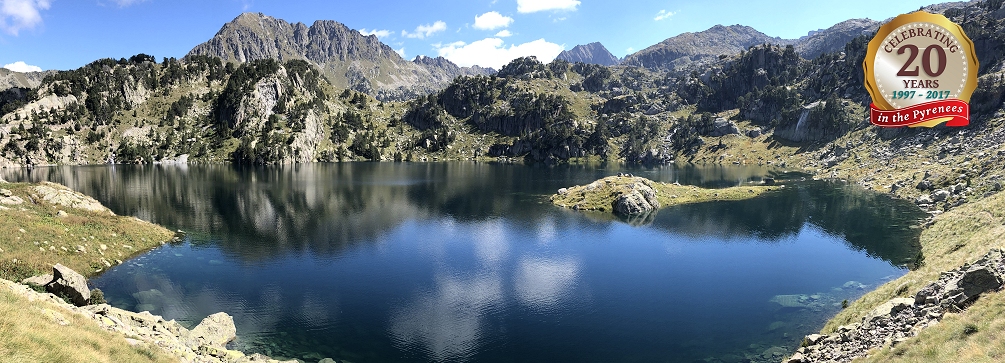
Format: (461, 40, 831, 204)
(0, 183, 173, 281)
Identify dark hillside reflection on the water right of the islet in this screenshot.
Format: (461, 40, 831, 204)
(652, 181, 926, 265)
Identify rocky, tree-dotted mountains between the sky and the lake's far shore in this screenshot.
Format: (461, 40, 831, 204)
(0, 1, 1005, 166)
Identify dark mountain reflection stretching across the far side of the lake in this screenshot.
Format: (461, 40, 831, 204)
(3, 163, 924, 264)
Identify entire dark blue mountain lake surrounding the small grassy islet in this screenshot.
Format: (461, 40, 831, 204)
(2, 163, 925, 363)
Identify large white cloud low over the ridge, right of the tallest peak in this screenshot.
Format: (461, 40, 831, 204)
(433, 38, 565, 69)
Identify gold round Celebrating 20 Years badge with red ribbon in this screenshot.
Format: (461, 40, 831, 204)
(862, 11, 979, 127)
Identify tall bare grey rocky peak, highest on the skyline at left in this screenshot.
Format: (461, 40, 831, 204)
(187, 13, 492, 101)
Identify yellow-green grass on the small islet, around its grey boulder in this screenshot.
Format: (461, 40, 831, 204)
(551, 176, 780, 212)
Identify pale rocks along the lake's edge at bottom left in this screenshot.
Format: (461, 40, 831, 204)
(0, 279, 296, 363)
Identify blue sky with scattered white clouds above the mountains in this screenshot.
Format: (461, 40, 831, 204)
(0, 0, 938, 70)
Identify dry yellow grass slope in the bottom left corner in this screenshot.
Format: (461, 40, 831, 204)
(0, 283, 177, 363)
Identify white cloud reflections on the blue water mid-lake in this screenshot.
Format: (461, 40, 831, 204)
(388, 216, 580, 362)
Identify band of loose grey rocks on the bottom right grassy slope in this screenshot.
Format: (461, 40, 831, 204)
(785, 248, 1005, 363)
